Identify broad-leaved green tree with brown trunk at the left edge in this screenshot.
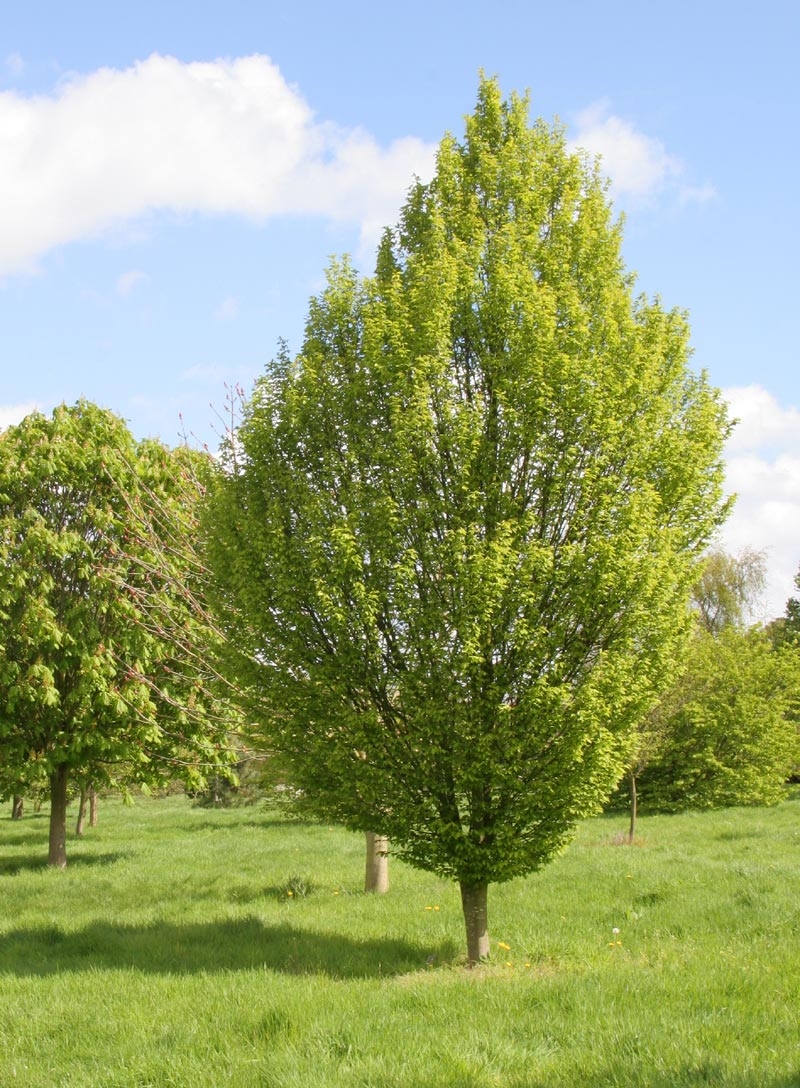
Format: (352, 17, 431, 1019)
(0, 401, 232, 867)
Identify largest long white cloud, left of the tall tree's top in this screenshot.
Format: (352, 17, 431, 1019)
(0, 54, 433, 274)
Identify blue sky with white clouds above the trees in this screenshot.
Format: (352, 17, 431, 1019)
(0, 0, 800, 620)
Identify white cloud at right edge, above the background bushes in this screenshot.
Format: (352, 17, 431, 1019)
(722, 385, 800, 620)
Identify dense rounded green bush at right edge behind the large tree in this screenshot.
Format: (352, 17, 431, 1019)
(639, 627, 800, 811)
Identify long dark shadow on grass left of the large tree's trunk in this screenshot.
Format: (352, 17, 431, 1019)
(0, 918, 456, 979)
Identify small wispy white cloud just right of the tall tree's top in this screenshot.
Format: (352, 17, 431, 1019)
(570, 100, 716, 203)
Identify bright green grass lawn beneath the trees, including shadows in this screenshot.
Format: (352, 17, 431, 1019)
(0, 795, 800, 1088)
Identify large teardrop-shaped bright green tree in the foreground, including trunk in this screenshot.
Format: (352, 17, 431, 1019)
(208, 81, 728, 963)
